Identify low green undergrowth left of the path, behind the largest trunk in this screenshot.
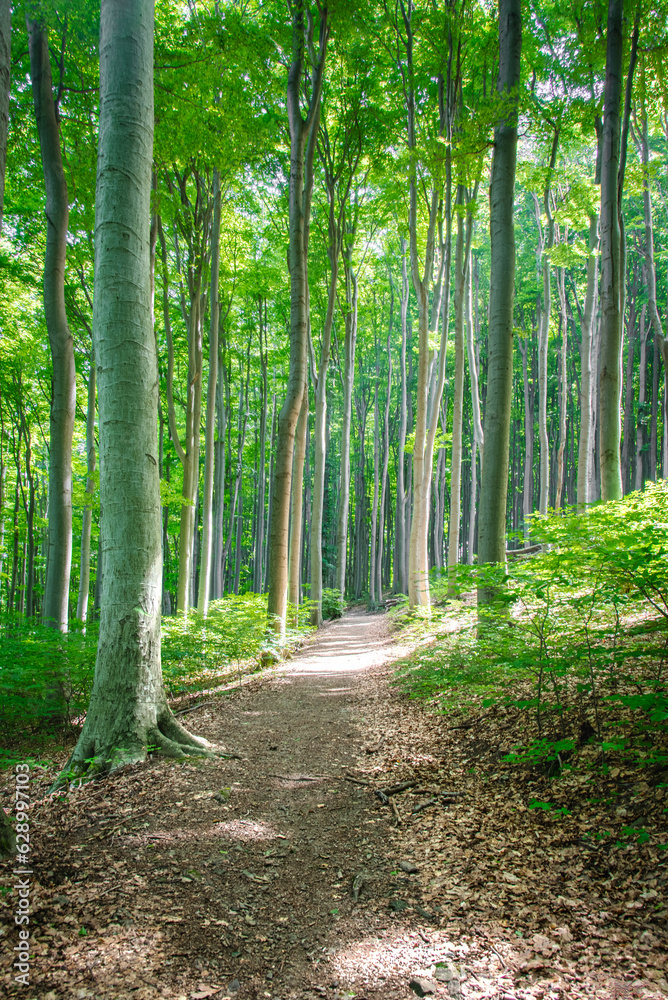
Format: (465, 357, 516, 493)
(0, 594, 320, 768)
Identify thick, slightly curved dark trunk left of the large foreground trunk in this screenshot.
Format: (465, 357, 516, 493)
(28, 20, 76, 632)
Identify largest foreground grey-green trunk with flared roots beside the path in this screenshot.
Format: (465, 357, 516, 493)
(59, 0, 210, 782)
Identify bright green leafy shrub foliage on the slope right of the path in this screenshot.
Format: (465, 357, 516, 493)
(399, 481, 668, 773)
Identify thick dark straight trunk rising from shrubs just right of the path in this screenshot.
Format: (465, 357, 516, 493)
(478, 0, 522, 588)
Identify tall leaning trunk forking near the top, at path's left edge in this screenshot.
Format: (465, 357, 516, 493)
(267, 0, 329, 640)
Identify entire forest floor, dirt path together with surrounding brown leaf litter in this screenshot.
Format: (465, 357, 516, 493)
(0, 610, 668, 1000)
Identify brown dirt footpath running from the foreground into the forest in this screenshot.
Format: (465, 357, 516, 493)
(17, 610, 444, 1000)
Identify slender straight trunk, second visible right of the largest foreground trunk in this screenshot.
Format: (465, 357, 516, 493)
(197, 170, 220, 618)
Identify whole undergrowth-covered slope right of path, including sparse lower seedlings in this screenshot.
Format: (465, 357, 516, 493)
(392, 482, 668, 860)
